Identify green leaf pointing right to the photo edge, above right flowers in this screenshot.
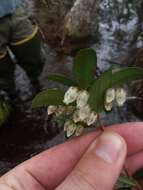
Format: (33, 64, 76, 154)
(112, 67, 143, 85)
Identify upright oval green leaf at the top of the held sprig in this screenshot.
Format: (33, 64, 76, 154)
(73, 49, 97, 89)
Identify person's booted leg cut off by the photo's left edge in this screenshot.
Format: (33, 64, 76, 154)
(0, 16, 15, 93)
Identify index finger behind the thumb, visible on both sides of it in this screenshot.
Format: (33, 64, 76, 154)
(0, 122, 143, 189)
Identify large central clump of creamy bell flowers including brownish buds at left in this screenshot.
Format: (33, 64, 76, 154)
(47, 87, 97, 137)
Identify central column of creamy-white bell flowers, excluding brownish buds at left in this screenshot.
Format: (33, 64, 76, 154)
(63, 87, 98, 137)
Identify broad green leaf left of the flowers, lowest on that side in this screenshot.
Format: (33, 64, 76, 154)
(32, 89, 64, 108)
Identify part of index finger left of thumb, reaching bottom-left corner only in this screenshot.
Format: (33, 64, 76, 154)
(0, 133, 97, 190)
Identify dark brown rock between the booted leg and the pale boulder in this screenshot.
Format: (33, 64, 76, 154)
(31, 0, 75, 44)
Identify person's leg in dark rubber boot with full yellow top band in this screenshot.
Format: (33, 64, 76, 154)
(11, 8, 43, 93)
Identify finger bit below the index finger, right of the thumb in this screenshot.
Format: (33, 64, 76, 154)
(126, 152, 143, 175)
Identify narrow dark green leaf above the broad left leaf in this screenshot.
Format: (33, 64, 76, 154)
(48, 74, 78, 86)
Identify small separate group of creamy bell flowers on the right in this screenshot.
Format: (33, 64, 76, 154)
(104, 88, 127, 111)
